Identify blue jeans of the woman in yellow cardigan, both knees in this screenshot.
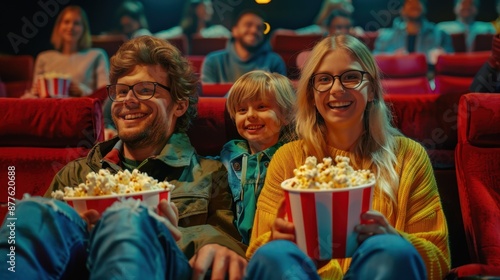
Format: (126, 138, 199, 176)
(246, 234, 427, 280)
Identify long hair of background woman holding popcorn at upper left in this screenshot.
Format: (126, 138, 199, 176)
(50, 5, 92, 51)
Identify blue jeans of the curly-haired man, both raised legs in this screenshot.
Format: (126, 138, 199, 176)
(0, 197, 192, 279)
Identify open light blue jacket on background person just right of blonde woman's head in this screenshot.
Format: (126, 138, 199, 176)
(373, 18, 453, 61)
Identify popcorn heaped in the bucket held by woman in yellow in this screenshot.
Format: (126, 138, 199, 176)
(285, 156, 375, 189)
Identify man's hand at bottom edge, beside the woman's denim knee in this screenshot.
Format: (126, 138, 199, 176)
(189, 244, 247, 280)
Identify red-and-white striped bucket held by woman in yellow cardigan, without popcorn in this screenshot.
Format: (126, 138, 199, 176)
(282, 179, 374, 260)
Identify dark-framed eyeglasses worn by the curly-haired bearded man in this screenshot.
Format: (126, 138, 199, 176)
(106, 82, 170, 102)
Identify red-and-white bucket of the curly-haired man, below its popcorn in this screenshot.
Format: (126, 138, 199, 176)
(63, 190, 170, 214)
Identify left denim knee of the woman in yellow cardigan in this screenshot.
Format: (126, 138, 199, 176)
(246, 240, 319, 279)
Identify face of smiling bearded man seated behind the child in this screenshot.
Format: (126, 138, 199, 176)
(232, 14, 264, 48)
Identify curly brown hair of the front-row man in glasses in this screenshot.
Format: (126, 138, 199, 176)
(109, 36, 199, 132)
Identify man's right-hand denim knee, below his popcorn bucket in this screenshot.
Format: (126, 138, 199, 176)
(87, 200, 190, 279)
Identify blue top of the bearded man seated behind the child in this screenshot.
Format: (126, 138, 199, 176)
(201, 39, 286, 83)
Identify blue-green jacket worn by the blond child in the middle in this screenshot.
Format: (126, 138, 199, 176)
(220, 140, 283, 245)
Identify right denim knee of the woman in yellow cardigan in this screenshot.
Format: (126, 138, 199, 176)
(344, 234, 427, 279)
